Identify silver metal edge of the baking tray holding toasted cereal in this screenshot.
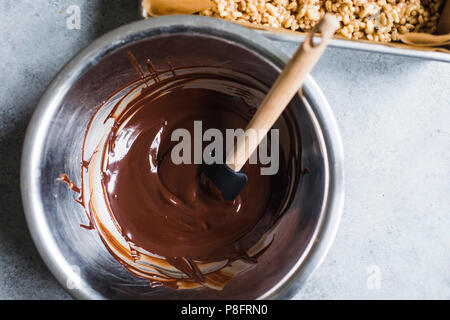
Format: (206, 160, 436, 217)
(139, 0, 450, 63)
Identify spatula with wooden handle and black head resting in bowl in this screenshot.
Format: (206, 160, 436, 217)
(203, 14, 339, 201)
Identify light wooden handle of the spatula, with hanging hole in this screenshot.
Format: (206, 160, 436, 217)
(226, 14, 339, 172)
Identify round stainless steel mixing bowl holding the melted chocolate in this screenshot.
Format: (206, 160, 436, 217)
(21, 16, 344, 299)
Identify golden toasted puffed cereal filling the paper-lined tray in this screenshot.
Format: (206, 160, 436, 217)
(201, 0, 443, 42)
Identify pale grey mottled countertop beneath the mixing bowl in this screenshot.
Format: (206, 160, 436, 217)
(0, 0, 450, 299)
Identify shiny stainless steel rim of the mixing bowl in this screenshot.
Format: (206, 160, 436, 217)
(20, 16, 344, 299)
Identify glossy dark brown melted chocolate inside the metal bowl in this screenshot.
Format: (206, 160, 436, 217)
(62, 53, 289, 288)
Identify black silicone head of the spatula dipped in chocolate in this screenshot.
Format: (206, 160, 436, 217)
(203, 163, 248, 201)
